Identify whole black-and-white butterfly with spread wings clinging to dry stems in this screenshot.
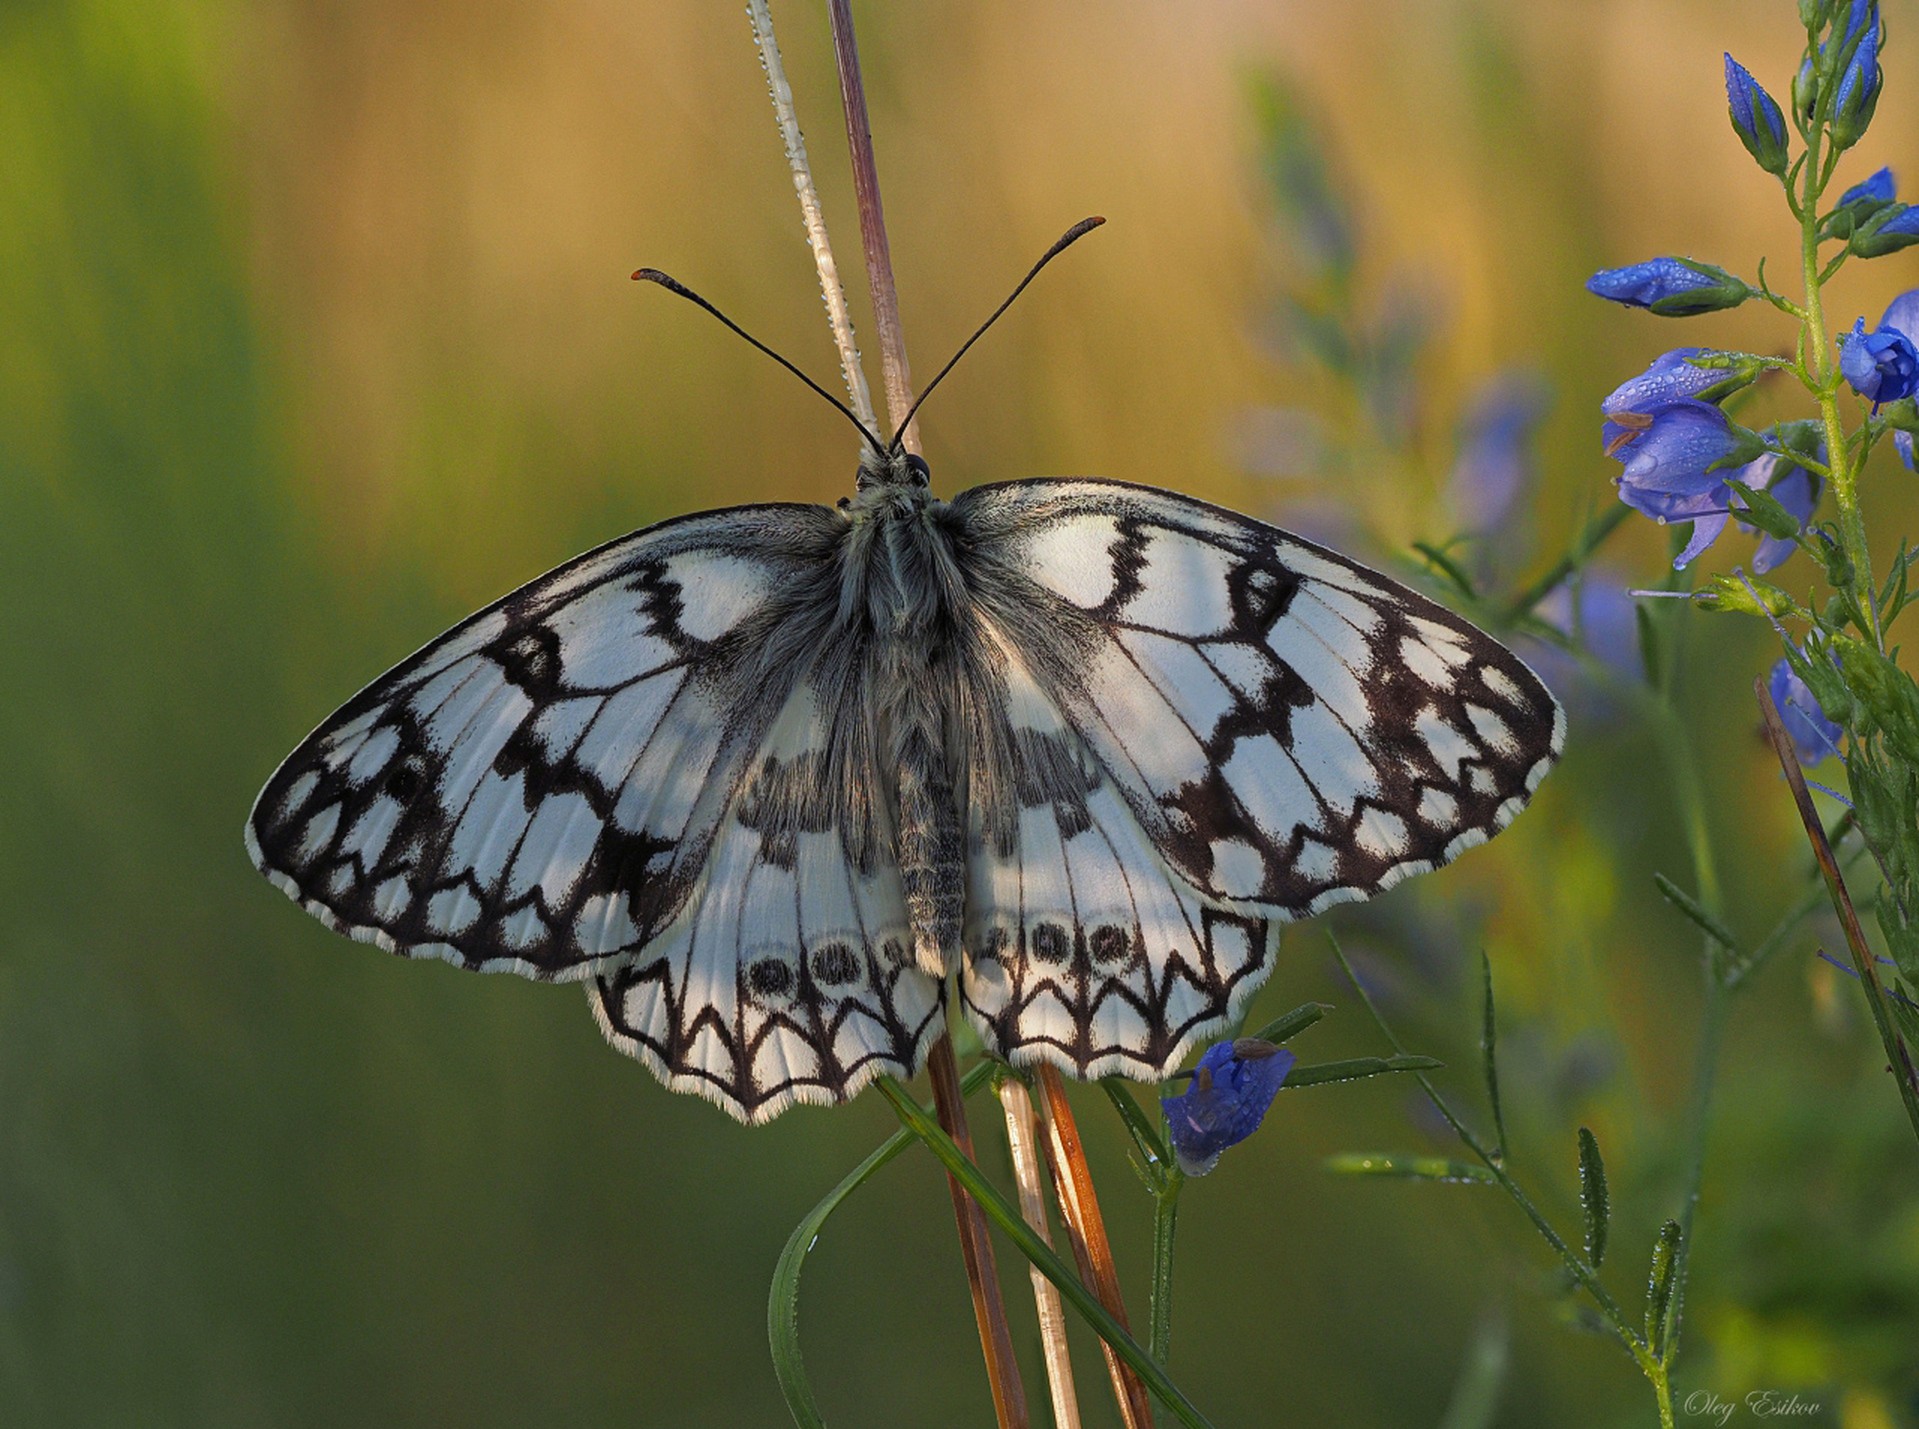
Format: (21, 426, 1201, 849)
(246, 222, 1566, 1122)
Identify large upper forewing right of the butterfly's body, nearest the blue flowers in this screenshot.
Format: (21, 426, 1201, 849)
(954, 480, 1564, 919)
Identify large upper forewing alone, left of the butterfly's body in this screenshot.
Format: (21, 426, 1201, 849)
(248, 504, 841, 978)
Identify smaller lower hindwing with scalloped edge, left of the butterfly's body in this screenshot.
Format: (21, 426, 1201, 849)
(589, 641, 944, 1122)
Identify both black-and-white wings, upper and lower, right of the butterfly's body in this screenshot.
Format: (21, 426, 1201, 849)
(954, 480, 1564, 1076)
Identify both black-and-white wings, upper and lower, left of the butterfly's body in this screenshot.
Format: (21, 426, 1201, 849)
(246, 504, 940, 1120)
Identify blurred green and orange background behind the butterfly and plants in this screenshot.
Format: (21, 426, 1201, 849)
(0, 0, 1919, 1429)
